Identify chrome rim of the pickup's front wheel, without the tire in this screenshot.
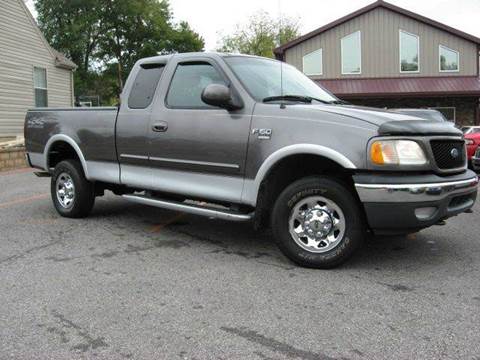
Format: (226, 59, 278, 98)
(288, 196, 346, 253)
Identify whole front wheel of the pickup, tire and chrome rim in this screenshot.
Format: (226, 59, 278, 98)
(271, 177, 364, 269)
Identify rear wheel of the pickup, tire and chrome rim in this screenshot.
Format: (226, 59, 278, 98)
(50, 160, 95, 218)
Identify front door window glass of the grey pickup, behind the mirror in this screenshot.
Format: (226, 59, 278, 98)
(167, 62, 226, 108)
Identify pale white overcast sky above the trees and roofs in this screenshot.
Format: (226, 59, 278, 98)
(25, 0, 480, 50)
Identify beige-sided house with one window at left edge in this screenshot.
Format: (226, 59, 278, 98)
(0, 0, 76, 137)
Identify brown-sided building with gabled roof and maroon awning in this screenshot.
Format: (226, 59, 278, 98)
(275, 1, 480, 124)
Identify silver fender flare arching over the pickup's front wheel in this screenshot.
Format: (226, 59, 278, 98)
(242, 144, 357, 206)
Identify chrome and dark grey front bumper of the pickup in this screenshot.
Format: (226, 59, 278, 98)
(354, 170, 478, 233)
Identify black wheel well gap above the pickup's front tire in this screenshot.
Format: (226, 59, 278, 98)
(255, 154, 356, 228)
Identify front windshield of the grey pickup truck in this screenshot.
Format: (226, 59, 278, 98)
(225, 56, 339, 102)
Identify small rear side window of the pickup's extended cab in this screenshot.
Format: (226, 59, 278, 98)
(128, 64, 165, 109)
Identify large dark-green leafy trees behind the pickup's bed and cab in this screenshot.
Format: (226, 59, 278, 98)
(35, 0, 204, 104)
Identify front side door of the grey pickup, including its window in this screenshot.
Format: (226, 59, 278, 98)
(148, 56, 252, 202)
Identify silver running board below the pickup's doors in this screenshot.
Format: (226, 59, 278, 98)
(122, 194, 253, 221)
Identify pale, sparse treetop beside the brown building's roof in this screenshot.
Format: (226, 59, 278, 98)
(218, 11, 300, 58)
